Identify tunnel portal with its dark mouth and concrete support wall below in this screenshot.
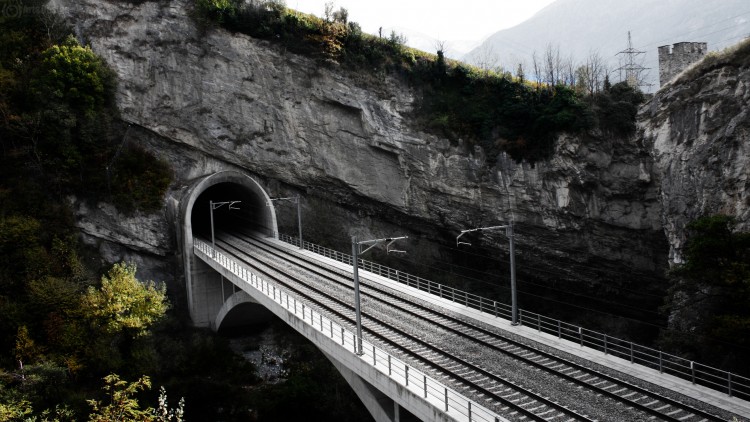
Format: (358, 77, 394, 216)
(178, 170, 278, 329)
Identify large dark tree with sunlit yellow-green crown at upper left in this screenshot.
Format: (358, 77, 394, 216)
(11, 36, 117, 192)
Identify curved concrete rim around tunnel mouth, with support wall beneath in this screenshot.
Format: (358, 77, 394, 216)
(179, 170, 279, 328)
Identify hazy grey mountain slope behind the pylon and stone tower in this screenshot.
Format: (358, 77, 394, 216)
(463, 0, 750, 88)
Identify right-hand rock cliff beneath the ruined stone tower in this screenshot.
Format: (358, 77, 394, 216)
(640, 47, 750, 263)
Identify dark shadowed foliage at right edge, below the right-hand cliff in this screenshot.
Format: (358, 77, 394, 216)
(662, 215, 750, 375)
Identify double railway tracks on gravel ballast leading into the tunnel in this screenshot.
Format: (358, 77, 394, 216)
(210, 233, 726, 421)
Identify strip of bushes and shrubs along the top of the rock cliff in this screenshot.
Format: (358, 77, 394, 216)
(194, 0, 643, 163)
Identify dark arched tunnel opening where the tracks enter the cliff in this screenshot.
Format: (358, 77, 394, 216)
(191, 182, 272, 240)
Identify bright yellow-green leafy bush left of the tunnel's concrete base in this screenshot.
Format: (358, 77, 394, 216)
(81, 263, 169, 337)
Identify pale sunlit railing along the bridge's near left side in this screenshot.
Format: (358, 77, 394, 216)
(193, 239, 506, 422)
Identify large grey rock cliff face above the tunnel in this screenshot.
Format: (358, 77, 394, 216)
(50, 0, 671, 294)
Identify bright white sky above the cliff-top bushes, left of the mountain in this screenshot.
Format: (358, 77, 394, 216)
(286, 0, 554, 41)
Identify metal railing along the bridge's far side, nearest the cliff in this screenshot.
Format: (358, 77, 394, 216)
(279, 234, 750, 400)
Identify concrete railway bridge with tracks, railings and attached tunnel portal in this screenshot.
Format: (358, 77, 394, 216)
(178, 171, 750, 422)
